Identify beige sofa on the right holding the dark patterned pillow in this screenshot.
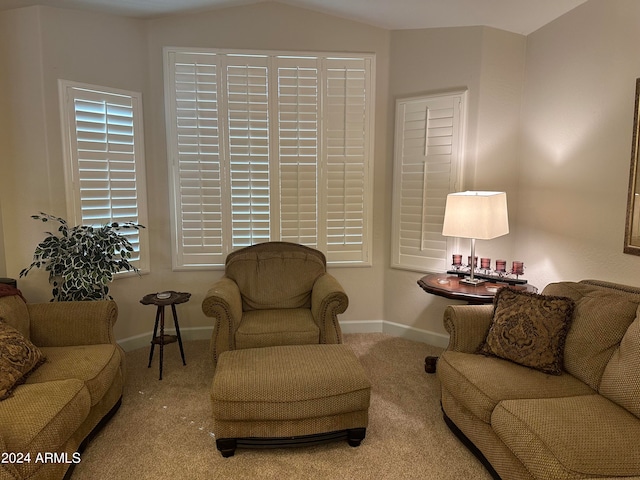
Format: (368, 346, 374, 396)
(437, 280, 640, 480)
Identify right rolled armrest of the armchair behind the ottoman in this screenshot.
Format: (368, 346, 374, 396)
(311, 273, 349, 343)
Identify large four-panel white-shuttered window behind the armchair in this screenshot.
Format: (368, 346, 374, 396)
(165, 48, 374, 269)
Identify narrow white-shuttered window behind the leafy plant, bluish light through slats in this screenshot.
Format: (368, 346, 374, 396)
(59, 80, 149, 271)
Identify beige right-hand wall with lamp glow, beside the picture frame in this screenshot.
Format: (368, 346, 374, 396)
(514, 0, 640, 287)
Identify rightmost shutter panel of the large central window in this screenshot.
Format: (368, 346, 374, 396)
(321, 58, 372, 263)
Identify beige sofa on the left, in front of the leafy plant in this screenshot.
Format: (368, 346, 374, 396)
(0, 295, 124, 480)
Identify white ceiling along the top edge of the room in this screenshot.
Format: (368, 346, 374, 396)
(0, 0, 587, 35)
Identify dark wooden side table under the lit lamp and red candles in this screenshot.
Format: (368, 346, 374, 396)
(418, 273, 538, 373)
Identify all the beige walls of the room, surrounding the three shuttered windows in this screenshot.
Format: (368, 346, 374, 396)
(0, 0, 640, 341)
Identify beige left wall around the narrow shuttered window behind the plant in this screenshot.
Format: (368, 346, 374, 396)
(0, 7, 149, 338)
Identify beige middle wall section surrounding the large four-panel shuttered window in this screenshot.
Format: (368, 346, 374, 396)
(138, 2, 389, 342)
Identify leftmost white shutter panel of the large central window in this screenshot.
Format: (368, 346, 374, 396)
(169, 52, 223, 265)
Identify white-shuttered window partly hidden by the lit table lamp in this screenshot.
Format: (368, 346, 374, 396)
(391, 92, 466, 272)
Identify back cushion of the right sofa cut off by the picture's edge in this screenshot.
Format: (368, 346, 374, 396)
(600, 317, 640, 417)
